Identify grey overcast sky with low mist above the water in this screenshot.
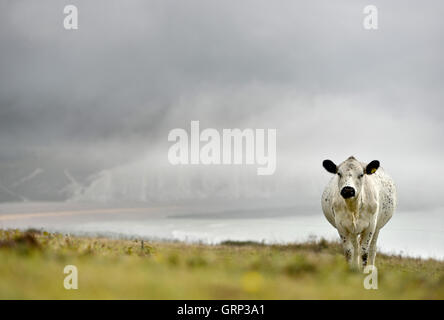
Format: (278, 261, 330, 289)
(0, 0, 444, 208)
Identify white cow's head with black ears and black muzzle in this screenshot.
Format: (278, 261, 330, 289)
(322, 157, 379, 199)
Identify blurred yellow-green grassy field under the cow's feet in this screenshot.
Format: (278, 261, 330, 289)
(0, 230, 444, 299)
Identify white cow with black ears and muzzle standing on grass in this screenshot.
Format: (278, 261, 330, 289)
(322, 157, 396, 270)
